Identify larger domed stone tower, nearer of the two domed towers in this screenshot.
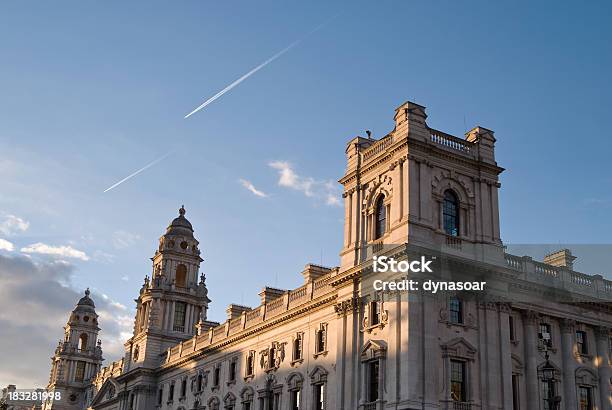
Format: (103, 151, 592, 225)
(124, 206, 210, 371)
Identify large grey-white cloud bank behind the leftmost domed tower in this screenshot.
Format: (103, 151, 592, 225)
(0, 255, 133, 388)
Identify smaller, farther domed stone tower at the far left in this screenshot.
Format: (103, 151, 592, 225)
(43, 289, 104, 410)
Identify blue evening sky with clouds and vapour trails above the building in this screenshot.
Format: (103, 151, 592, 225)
(0, 1, 612, 387)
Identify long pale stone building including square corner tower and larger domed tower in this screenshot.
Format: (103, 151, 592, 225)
(45, 102, 612, 410)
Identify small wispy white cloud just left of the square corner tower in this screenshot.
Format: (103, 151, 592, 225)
(268, 161, 340, 206)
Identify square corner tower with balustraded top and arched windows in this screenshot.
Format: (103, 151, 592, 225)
(340, 102, 503, 270)
